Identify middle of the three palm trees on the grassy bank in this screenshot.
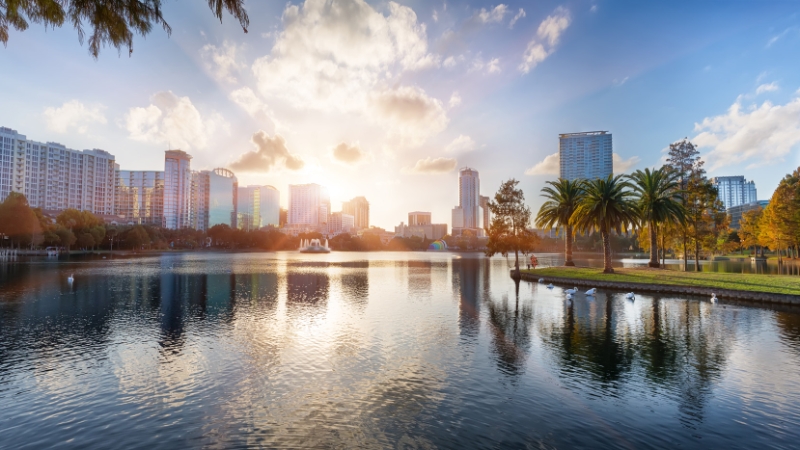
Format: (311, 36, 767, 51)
(572, 175, 638, 273)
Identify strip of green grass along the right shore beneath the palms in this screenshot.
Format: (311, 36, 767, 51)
(521, 266, 800, 298)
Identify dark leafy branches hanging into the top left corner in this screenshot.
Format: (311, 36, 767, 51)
(0, 0, 250, 59)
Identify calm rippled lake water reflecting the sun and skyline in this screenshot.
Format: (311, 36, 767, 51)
(0, 253, 800, 449)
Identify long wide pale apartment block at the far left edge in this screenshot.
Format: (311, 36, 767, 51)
(0, 127, 116, 214)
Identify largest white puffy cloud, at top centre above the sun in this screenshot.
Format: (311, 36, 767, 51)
(253, 0, 439, 112)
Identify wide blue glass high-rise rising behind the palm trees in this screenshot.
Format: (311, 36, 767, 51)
(558, 131, 614, 180)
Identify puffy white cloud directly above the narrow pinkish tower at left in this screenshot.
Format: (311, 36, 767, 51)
(125, 91, 230, 150)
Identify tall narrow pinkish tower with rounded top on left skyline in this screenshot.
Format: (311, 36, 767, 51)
(164, 150, 192, 230)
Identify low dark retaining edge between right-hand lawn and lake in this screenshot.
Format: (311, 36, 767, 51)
(520, 272, 800, 305)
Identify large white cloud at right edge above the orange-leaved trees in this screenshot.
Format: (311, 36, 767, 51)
(693, 93, 800, 170)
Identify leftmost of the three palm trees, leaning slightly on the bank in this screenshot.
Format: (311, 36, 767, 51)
(536, 178, 584, 266)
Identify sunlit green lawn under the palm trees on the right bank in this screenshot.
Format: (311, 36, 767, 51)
(522, 267, 800, 295)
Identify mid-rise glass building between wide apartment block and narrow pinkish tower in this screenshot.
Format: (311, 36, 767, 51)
(114, 170, 164, 227)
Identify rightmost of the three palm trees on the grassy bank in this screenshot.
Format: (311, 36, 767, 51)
(628, 167, 685, 267)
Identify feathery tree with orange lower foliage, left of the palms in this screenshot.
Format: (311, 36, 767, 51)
(486, 178, 539, 278)
